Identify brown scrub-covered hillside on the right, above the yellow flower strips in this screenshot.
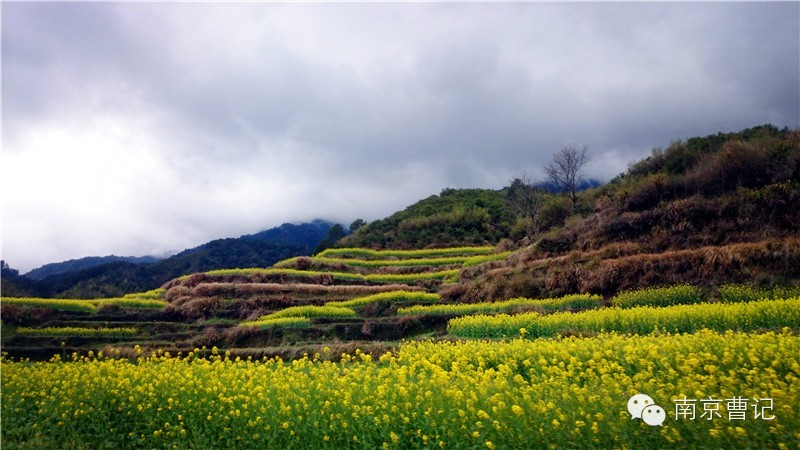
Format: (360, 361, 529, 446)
(448, 126, 800, 301)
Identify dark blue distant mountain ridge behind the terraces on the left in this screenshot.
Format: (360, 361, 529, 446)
(13, 220, 331, 298)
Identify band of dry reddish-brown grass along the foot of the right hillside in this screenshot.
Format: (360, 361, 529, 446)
(456, 237, 800, 302)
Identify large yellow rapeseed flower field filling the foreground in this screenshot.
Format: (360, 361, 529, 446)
(2, 329, 800, 449)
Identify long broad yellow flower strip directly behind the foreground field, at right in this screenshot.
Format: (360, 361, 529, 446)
(447, 298, 800, 338)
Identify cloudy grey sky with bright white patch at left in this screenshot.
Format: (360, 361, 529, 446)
(0, 2, 800, 273)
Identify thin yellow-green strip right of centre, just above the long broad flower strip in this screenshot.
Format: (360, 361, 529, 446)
(397, 294, 602, 316)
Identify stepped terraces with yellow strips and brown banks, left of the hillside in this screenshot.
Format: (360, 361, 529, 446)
(2, 247, 500, 359)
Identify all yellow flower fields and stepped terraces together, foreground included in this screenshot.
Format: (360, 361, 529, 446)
(2, 247, 800, 449)
